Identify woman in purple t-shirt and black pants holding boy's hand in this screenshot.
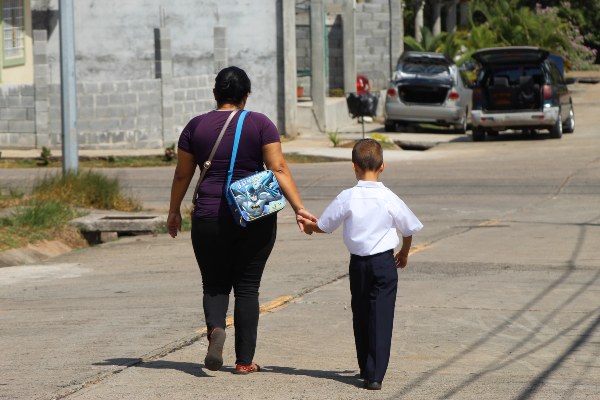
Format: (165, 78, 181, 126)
(167, 67, 316, 374)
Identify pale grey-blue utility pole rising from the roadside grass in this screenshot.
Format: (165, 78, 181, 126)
(59, 0, 79, 174)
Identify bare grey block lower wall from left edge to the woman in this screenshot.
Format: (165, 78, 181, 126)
(0, 74, 215, 149)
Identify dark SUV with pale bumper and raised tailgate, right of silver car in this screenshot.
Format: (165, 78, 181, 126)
(471, 47, 575, 141)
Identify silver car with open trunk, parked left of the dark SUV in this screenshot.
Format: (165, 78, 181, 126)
(384, 51, 472, 133)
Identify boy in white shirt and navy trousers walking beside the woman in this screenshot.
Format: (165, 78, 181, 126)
(302, 139, 423, 390)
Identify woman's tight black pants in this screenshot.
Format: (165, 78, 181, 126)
(192, 216, 277, 365)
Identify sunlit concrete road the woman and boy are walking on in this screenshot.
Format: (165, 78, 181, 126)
(0, 82, 600, 399)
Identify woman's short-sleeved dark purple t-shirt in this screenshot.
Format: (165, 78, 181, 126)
(178, 110, 280, 218)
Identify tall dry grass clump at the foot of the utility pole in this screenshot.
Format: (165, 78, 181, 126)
(32, 171, 142, 211)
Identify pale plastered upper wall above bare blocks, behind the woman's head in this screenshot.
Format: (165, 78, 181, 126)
(31, 0, 282, 131)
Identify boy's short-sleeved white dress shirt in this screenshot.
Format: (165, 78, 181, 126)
(317, 181, 423, 256)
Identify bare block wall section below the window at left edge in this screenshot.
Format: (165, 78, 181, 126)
(0, 85, 36, 148)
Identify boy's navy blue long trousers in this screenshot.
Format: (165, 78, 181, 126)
(350, 250, 398, 382)
